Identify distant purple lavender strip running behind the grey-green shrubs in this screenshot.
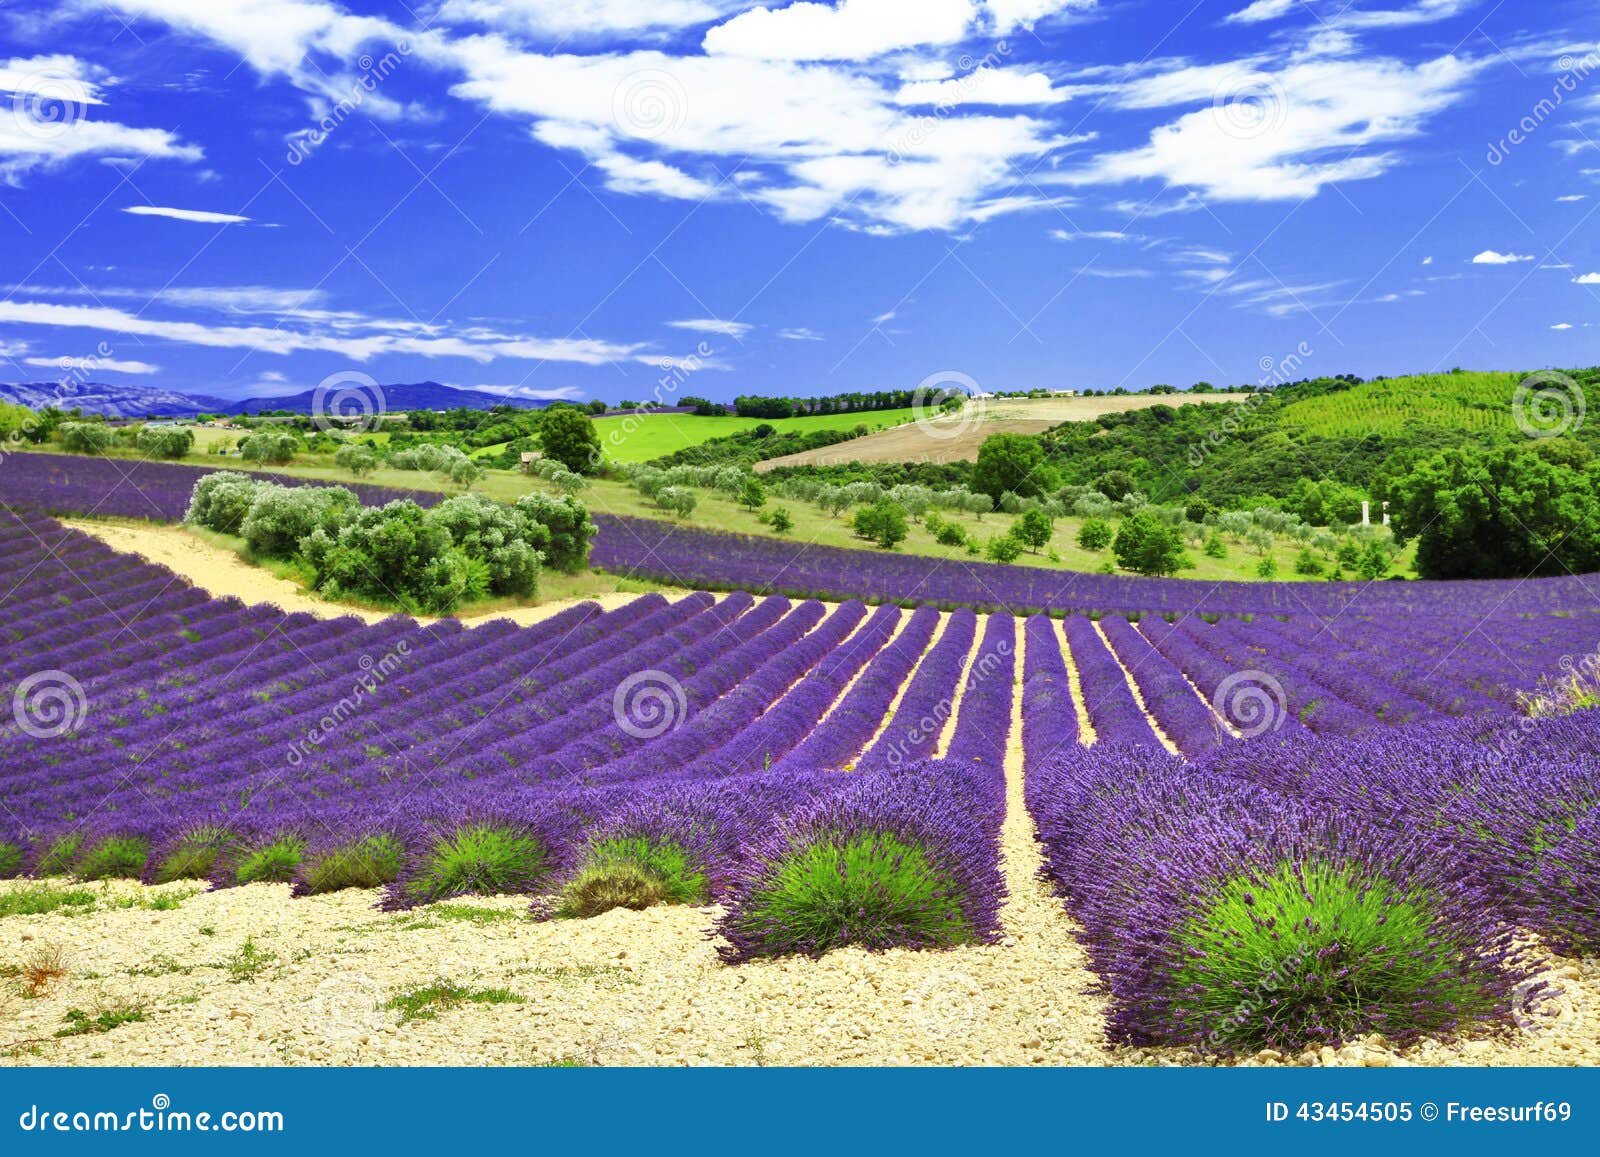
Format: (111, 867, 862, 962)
(0, 453, 1600, 624)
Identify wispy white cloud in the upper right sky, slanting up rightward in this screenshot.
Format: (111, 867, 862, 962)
(1035, 56, 1482, 202)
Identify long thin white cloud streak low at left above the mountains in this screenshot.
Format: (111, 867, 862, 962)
(0, 301, 661, 365)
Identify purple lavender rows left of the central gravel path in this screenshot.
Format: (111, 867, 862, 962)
(0, 517, 1003, 959)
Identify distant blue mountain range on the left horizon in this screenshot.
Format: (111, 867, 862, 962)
(0, 381, 550, 418)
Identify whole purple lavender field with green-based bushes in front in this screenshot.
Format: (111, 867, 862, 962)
(0, 459, 1600, 1056)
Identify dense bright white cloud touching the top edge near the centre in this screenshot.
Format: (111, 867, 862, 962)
(704, 0, 978, 61)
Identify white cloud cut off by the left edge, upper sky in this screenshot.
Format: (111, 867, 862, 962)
(0, 54, 203, 184)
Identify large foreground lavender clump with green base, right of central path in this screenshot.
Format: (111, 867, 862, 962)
(1024, 713, 1600, 1051)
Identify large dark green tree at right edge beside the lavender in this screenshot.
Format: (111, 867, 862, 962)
(1388, 446, 1600, 579)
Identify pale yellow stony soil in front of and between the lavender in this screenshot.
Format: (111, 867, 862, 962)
(0, 526, 1600, 1066)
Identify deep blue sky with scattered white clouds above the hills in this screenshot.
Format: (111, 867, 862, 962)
(0, 0, 1600, 402)
